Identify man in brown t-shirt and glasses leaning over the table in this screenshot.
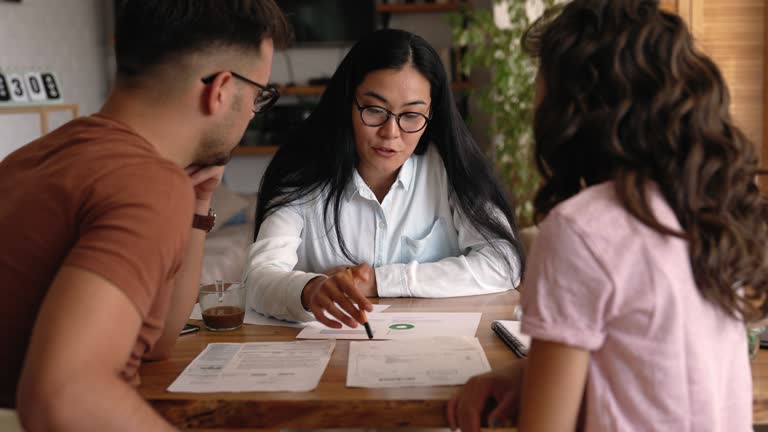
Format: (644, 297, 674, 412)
(0, 0, 289, 431)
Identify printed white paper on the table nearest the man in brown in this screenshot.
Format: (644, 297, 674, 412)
(168, 341, 336, 393)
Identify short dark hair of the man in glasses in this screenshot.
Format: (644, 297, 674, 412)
(115, 0, 291, 77)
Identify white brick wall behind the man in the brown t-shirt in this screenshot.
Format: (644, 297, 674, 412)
(0, 0, 109, 159)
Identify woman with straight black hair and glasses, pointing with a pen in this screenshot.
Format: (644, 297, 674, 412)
(244, 29, 524, 328)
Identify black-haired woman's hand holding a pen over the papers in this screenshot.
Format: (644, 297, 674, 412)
(301, 264, 376, 328)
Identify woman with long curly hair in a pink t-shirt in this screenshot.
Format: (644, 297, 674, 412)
(448, 0, 768, 431)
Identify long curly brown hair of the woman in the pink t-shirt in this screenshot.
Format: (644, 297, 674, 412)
(523, 0, 768, 319)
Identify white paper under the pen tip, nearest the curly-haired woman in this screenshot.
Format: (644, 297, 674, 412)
(347, 336, 491, 388)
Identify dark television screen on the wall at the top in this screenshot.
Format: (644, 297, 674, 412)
(277, 0, 376, 45)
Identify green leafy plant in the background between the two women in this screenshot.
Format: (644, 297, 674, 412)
(451, 0, 556, 227)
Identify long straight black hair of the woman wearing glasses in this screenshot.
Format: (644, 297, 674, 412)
(254, 29, 524, 272)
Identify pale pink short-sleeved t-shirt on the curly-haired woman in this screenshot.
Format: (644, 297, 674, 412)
(522, 182, 752, 432)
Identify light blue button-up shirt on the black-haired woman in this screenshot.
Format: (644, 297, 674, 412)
(243, 146, 520, 321)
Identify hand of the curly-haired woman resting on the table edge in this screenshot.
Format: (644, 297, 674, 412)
(447, 360, 525, 432)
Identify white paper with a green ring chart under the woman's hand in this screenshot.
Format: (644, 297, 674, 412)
(296, 312, 482, 339)
